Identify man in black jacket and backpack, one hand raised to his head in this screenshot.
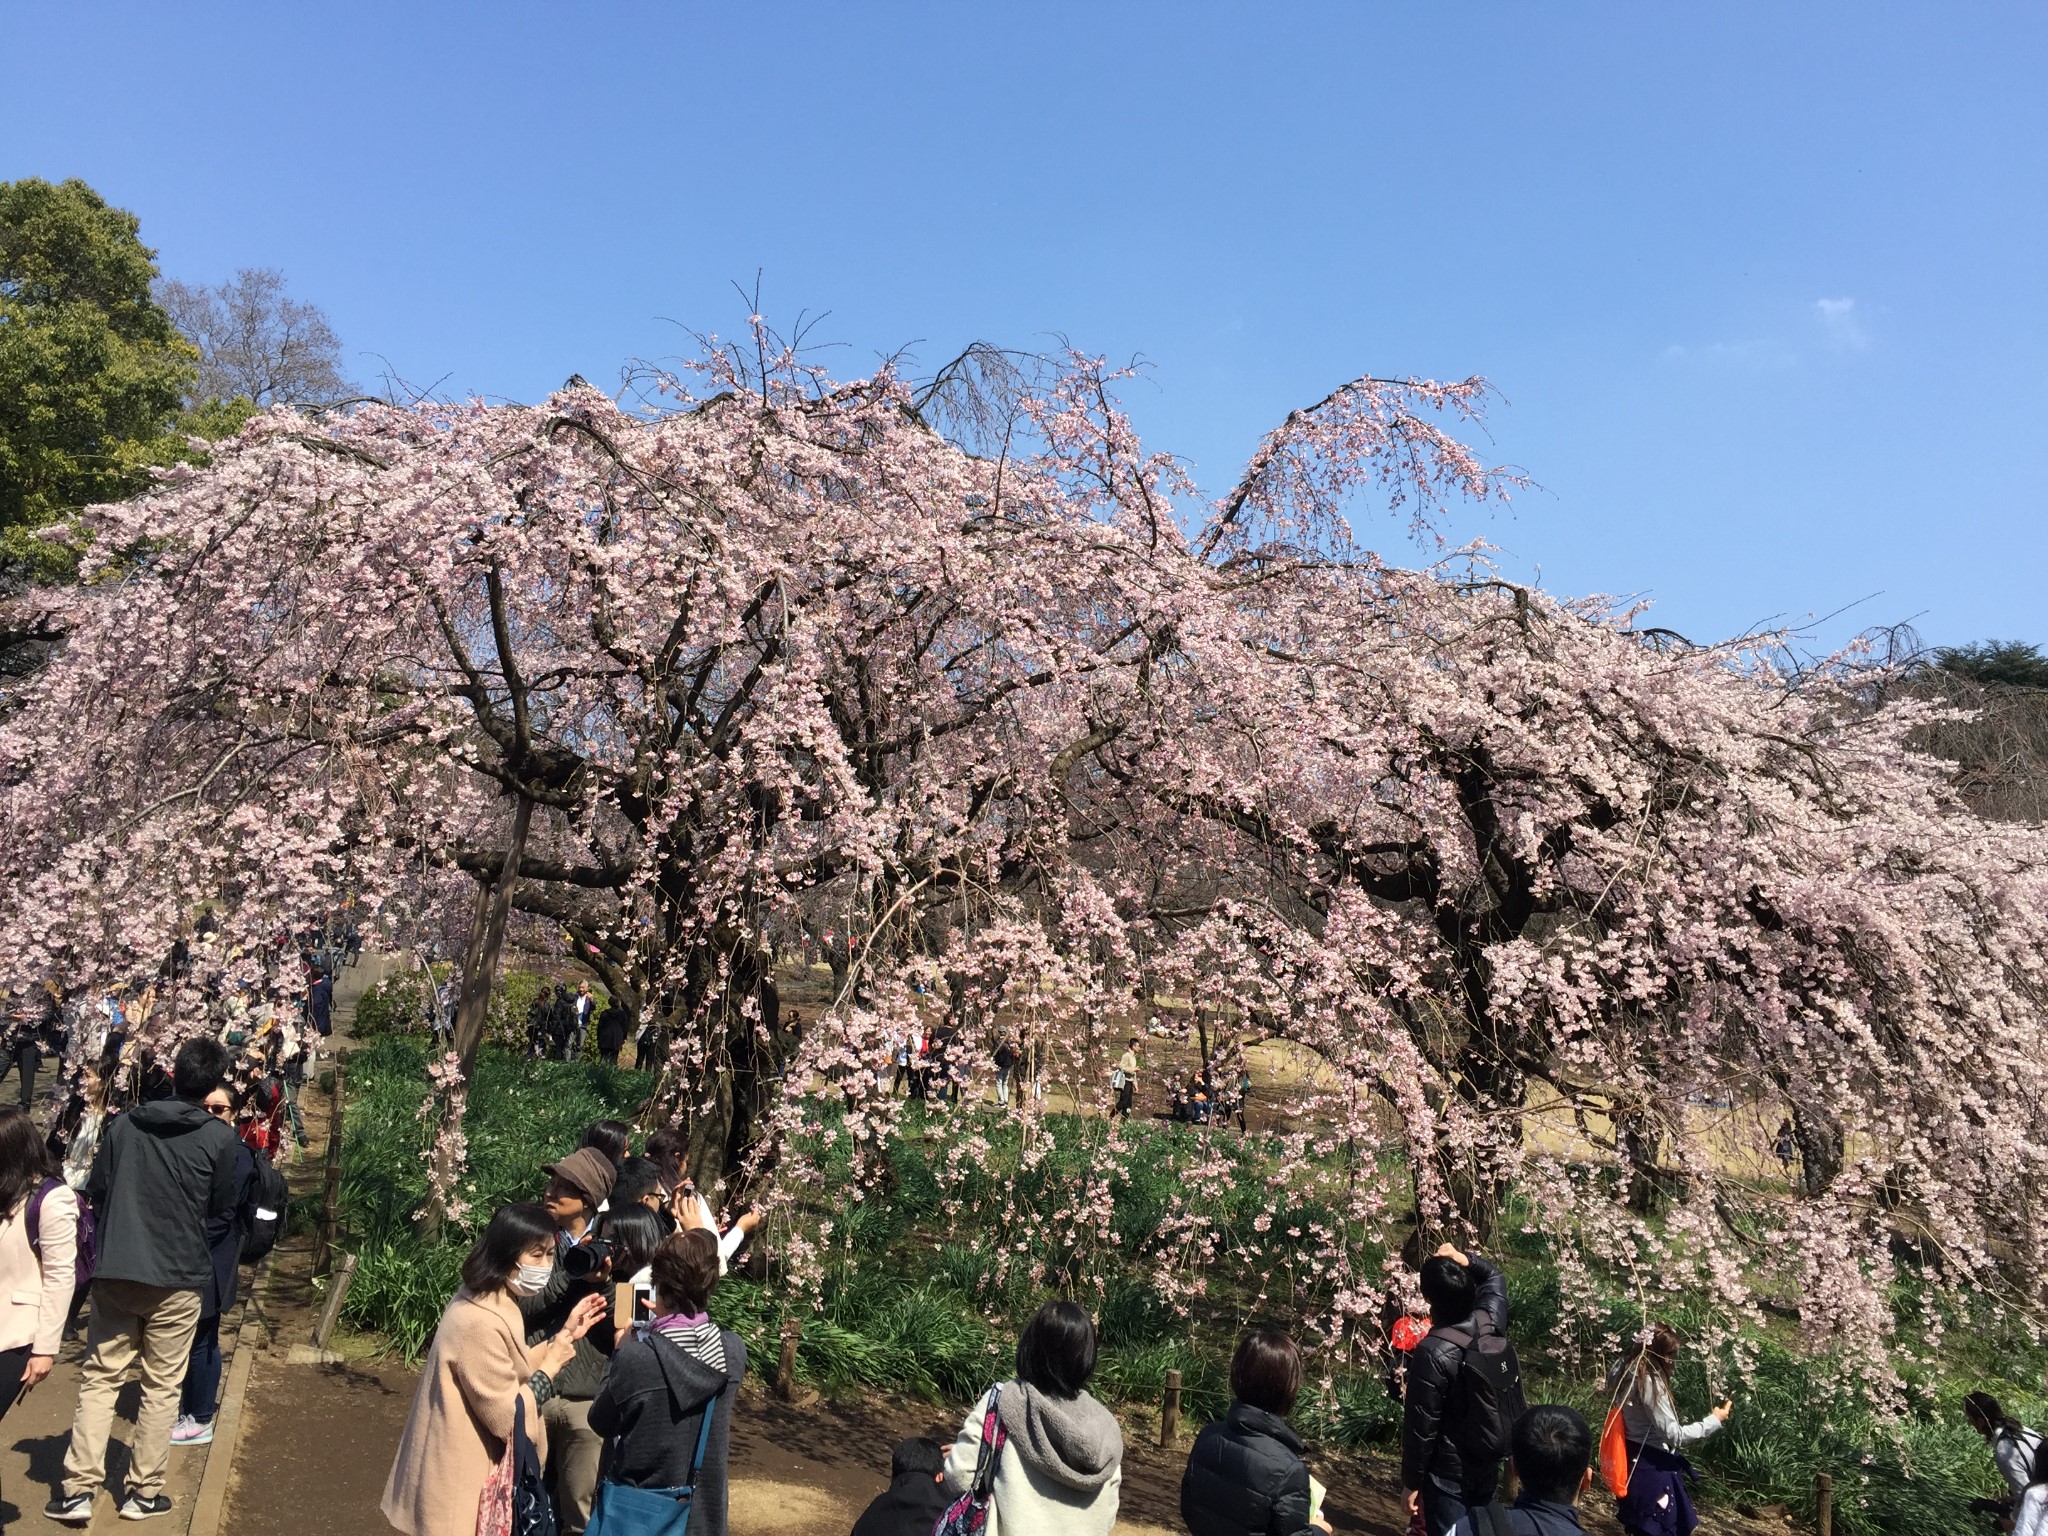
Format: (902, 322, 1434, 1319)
(1401, 1243, 1507, 1536)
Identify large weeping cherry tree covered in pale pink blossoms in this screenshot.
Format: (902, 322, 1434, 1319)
(0, 332, 2048, 1382)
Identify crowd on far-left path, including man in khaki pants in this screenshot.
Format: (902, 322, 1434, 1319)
(0, 930, 331, 1526)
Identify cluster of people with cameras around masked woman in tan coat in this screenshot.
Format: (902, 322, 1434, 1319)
(383, 1120, 760, 1536)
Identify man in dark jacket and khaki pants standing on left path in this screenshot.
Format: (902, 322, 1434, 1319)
(43, 1040, 240, 1526)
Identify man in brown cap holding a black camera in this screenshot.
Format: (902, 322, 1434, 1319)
(518, 1147, 623, 1536)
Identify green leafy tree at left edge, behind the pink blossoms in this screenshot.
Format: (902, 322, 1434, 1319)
(0, 178, 197, 540)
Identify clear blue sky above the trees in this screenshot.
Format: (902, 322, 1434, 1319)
(0, 0, 2048, 643)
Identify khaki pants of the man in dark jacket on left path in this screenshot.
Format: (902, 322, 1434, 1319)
(63, 1280, 199, 1497)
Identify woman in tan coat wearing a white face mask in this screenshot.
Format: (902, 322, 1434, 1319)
(383, 1202, 604, 1536)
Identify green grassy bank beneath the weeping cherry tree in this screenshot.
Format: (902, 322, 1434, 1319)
(342, 1036, 2044, 1536)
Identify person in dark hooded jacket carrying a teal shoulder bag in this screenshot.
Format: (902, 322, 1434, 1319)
(590, 1227, 748, 1536)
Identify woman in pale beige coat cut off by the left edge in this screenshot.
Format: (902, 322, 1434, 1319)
(0, 1108, 78, 1413)
